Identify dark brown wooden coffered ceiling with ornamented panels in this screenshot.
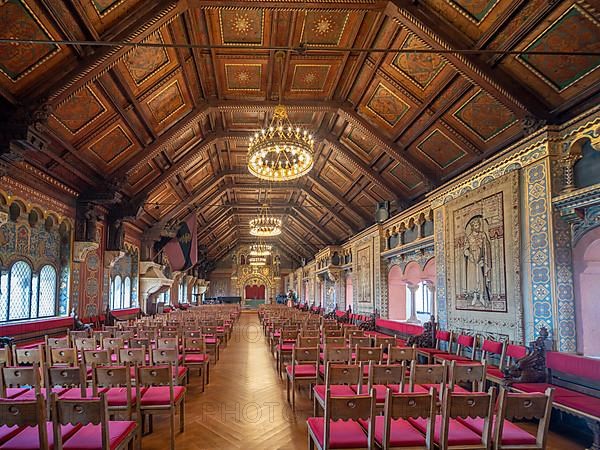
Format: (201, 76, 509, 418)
(0, 0, 600, 260)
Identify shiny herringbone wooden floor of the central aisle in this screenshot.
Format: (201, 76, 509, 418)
(142, 313, 584, 450)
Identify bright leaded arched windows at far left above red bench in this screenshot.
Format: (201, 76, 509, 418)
(0, 260, 58, 322)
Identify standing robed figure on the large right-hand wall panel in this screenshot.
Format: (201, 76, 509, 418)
(464, 215, 492, 306)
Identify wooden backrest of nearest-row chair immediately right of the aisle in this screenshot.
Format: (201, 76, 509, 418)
(323, 388, 376, 448)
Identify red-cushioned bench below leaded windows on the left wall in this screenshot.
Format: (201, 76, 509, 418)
(0, 317, 73, 347)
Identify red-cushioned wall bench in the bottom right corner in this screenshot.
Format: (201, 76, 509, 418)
(511, 352, 600, 450)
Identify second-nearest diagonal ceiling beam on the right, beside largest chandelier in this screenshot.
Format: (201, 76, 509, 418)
(338, 104, 435, 186)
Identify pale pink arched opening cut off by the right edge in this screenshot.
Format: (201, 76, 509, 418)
(573, 228, 600, 356)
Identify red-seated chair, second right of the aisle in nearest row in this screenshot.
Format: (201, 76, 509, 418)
(374, 388, 437, 450)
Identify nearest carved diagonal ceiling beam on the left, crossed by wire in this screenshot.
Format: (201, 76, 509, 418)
(47, 0, 187, 105)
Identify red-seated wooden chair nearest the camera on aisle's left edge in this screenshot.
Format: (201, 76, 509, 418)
(136, 365, 185, 450)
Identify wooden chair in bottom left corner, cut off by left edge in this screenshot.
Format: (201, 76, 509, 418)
(0, 394, 48, 450)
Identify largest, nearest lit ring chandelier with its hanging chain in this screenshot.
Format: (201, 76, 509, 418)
(248, 51, 314, 181)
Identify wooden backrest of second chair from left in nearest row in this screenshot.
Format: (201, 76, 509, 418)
(52, 393, 111, 449)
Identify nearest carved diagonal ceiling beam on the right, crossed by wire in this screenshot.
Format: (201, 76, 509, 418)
(386, 0, 550, 119)
